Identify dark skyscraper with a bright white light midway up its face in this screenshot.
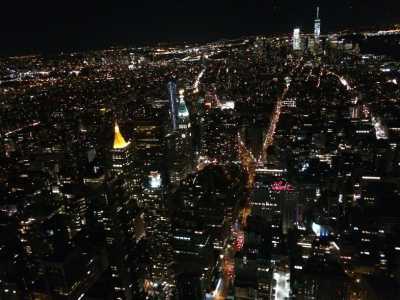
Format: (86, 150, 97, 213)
(133, 104, 177, 299)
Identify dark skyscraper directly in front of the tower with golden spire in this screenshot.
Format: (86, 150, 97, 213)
(91, 176, 136, 300)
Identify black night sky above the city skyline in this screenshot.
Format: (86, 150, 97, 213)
(0, 0, 400, 55)
